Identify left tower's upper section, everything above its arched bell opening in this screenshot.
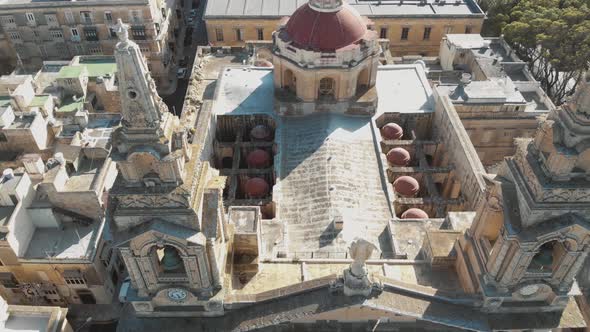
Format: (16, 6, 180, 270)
(111, 21, 198, 228)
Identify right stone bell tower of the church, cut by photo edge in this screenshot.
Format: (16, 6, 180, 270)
(457, 71, 590, 312)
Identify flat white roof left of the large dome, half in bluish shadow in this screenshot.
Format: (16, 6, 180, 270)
(214, 67, 274, 115)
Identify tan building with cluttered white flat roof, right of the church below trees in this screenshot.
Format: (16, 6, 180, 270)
(429, 34, 555, 167)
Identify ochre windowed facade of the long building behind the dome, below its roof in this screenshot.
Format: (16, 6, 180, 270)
(205, 0, 484, 56)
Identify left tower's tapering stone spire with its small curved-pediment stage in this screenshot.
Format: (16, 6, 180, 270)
(114, 20, 190, 187)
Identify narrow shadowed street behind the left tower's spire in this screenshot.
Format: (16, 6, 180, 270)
(163, 0, 208, 115)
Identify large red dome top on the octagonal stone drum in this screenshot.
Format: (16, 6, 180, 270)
(287, 3, 367, 51)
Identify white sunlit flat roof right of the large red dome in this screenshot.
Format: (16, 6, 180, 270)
(376, 64, 434, 114)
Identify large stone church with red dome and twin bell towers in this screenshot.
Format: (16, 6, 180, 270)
(115, 0, 590, 331)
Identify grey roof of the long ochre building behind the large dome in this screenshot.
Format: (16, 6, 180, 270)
(205, 0, 484, 19)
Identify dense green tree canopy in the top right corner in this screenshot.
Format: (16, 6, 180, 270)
(503, 0, 590, 105)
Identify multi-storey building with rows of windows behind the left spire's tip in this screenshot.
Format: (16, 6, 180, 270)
(0, 0, 182, 88)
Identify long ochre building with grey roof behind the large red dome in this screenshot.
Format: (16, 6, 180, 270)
(204, 0, 485, 56)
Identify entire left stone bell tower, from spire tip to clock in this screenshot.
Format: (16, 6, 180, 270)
(109, 20, 227, 317)
